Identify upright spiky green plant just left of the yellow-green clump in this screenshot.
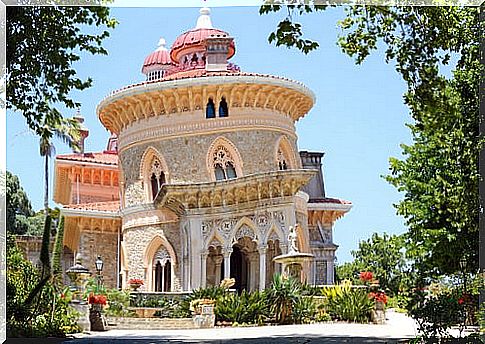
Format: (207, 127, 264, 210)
(267, 274, 301, 324)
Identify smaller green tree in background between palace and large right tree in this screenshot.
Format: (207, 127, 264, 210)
(337, 233, 409, 295)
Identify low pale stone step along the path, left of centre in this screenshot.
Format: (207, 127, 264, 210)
(108, 317, 196, 330)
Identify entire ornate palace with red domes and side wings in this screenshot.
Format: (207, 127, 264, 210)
(54, 8, 352, 292)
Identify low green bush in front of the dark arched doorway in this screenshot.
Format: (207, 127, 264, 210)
(215, 290, 269, 325)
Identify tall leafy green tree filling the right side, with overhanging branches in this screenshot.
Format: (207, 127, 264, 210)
(260, 5, 483, 278)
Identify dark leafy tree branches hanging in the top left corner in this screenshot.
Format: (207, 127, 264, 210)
(6, 5, 116, 136)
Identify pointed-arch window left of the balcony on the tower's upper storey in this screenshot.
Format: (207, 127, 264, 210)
(140, 146, 170, 202)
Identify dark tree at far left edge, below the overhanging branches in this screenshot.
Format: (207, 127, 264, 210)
(6, 171, 34, 234)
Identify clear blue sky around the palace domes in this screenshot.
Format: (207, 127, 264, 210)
(7, 5, 411, 262)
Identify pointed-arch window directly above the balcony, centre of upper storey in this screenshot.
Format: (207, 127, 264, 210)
(206, 136, 243, 181)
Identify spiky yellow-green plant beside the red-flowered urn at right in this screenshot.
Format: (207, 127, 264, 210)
(322, 283, 374, 323)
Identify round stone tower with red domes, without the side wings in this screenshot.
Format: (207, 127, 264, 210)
(97, 8, 315, 291)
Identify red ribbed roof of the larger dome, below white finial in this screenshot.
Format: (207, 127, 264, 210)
(170, 28, 236, 63)
